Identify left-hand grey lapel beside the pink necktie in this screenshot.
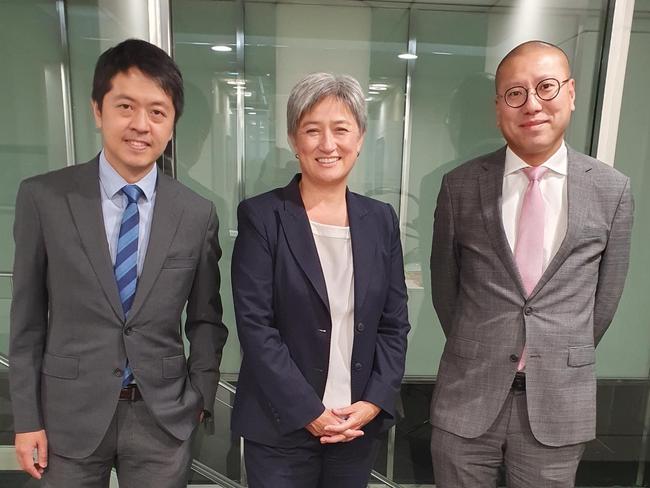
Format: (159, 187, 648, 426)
(478, 147, 526, 297)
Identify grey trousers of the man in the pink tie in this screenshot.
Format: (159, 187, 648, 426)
(431, 391, 585, 488)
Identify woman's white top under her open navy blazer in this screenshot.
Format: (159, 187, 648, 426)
(310, 221, 354, 408)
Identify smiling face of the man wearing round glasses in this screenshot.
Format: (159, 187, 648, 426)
(496, 47, 575, 166)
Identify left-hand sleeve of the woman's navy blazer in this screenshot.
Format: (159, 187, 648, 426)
(232, 201, 325, 433)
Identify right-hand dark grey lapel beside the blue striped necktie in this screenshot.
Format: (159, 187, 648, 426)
(129, 170, 184, 321)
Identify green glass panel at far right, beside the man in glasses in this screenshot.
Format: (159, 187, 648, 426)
(597, 0, 650, 378)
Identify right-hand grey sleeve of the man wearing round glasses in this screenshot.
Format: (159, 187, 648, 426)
(594, 179, 634, 345)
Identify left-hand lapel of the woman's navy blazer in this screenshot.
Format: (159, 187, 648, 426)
(279, 175, 330, 311)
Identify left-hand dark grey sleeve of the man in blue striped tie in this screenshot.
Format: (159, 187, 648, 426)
(9, 182, 48, 433)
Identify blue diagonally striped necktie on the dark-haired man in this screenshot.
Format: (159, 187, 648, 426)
(115, 185, 143, 387)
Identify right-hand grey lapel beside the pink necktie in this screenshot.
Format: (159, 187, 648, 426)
(531, 146, 595, 298)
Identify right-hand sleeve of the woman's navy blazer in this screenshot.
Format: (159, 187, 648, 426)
(362, 206, 411, 417)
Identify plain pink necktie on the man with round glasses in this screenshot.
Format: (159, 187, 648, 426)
(515, 166, 548, 371)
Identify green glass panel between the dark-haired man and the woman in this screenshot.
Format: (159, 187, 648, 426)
(171, 0, 241, 376)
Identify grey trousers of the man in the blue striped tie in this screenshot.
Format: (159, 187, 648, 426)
(41, 400, 192, 488)
